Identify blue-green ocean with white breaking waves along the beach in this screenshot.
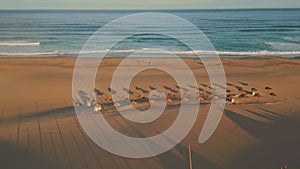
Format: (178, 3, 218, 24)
(0, 9, 300, 57)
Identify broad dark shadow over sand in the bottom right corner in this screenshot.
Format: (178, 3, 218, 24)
(224, 110, 300, 169)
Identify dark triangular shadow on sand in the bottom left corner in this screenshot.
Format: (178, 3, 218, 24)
(0, 140, 55, 169)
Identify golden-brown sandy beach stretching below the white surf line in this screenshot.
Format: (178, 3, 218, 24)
(0, 57, 300, 169)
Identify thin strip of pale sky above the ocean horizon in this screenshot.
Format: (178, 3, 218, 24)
(0, 0, 300, 9)
